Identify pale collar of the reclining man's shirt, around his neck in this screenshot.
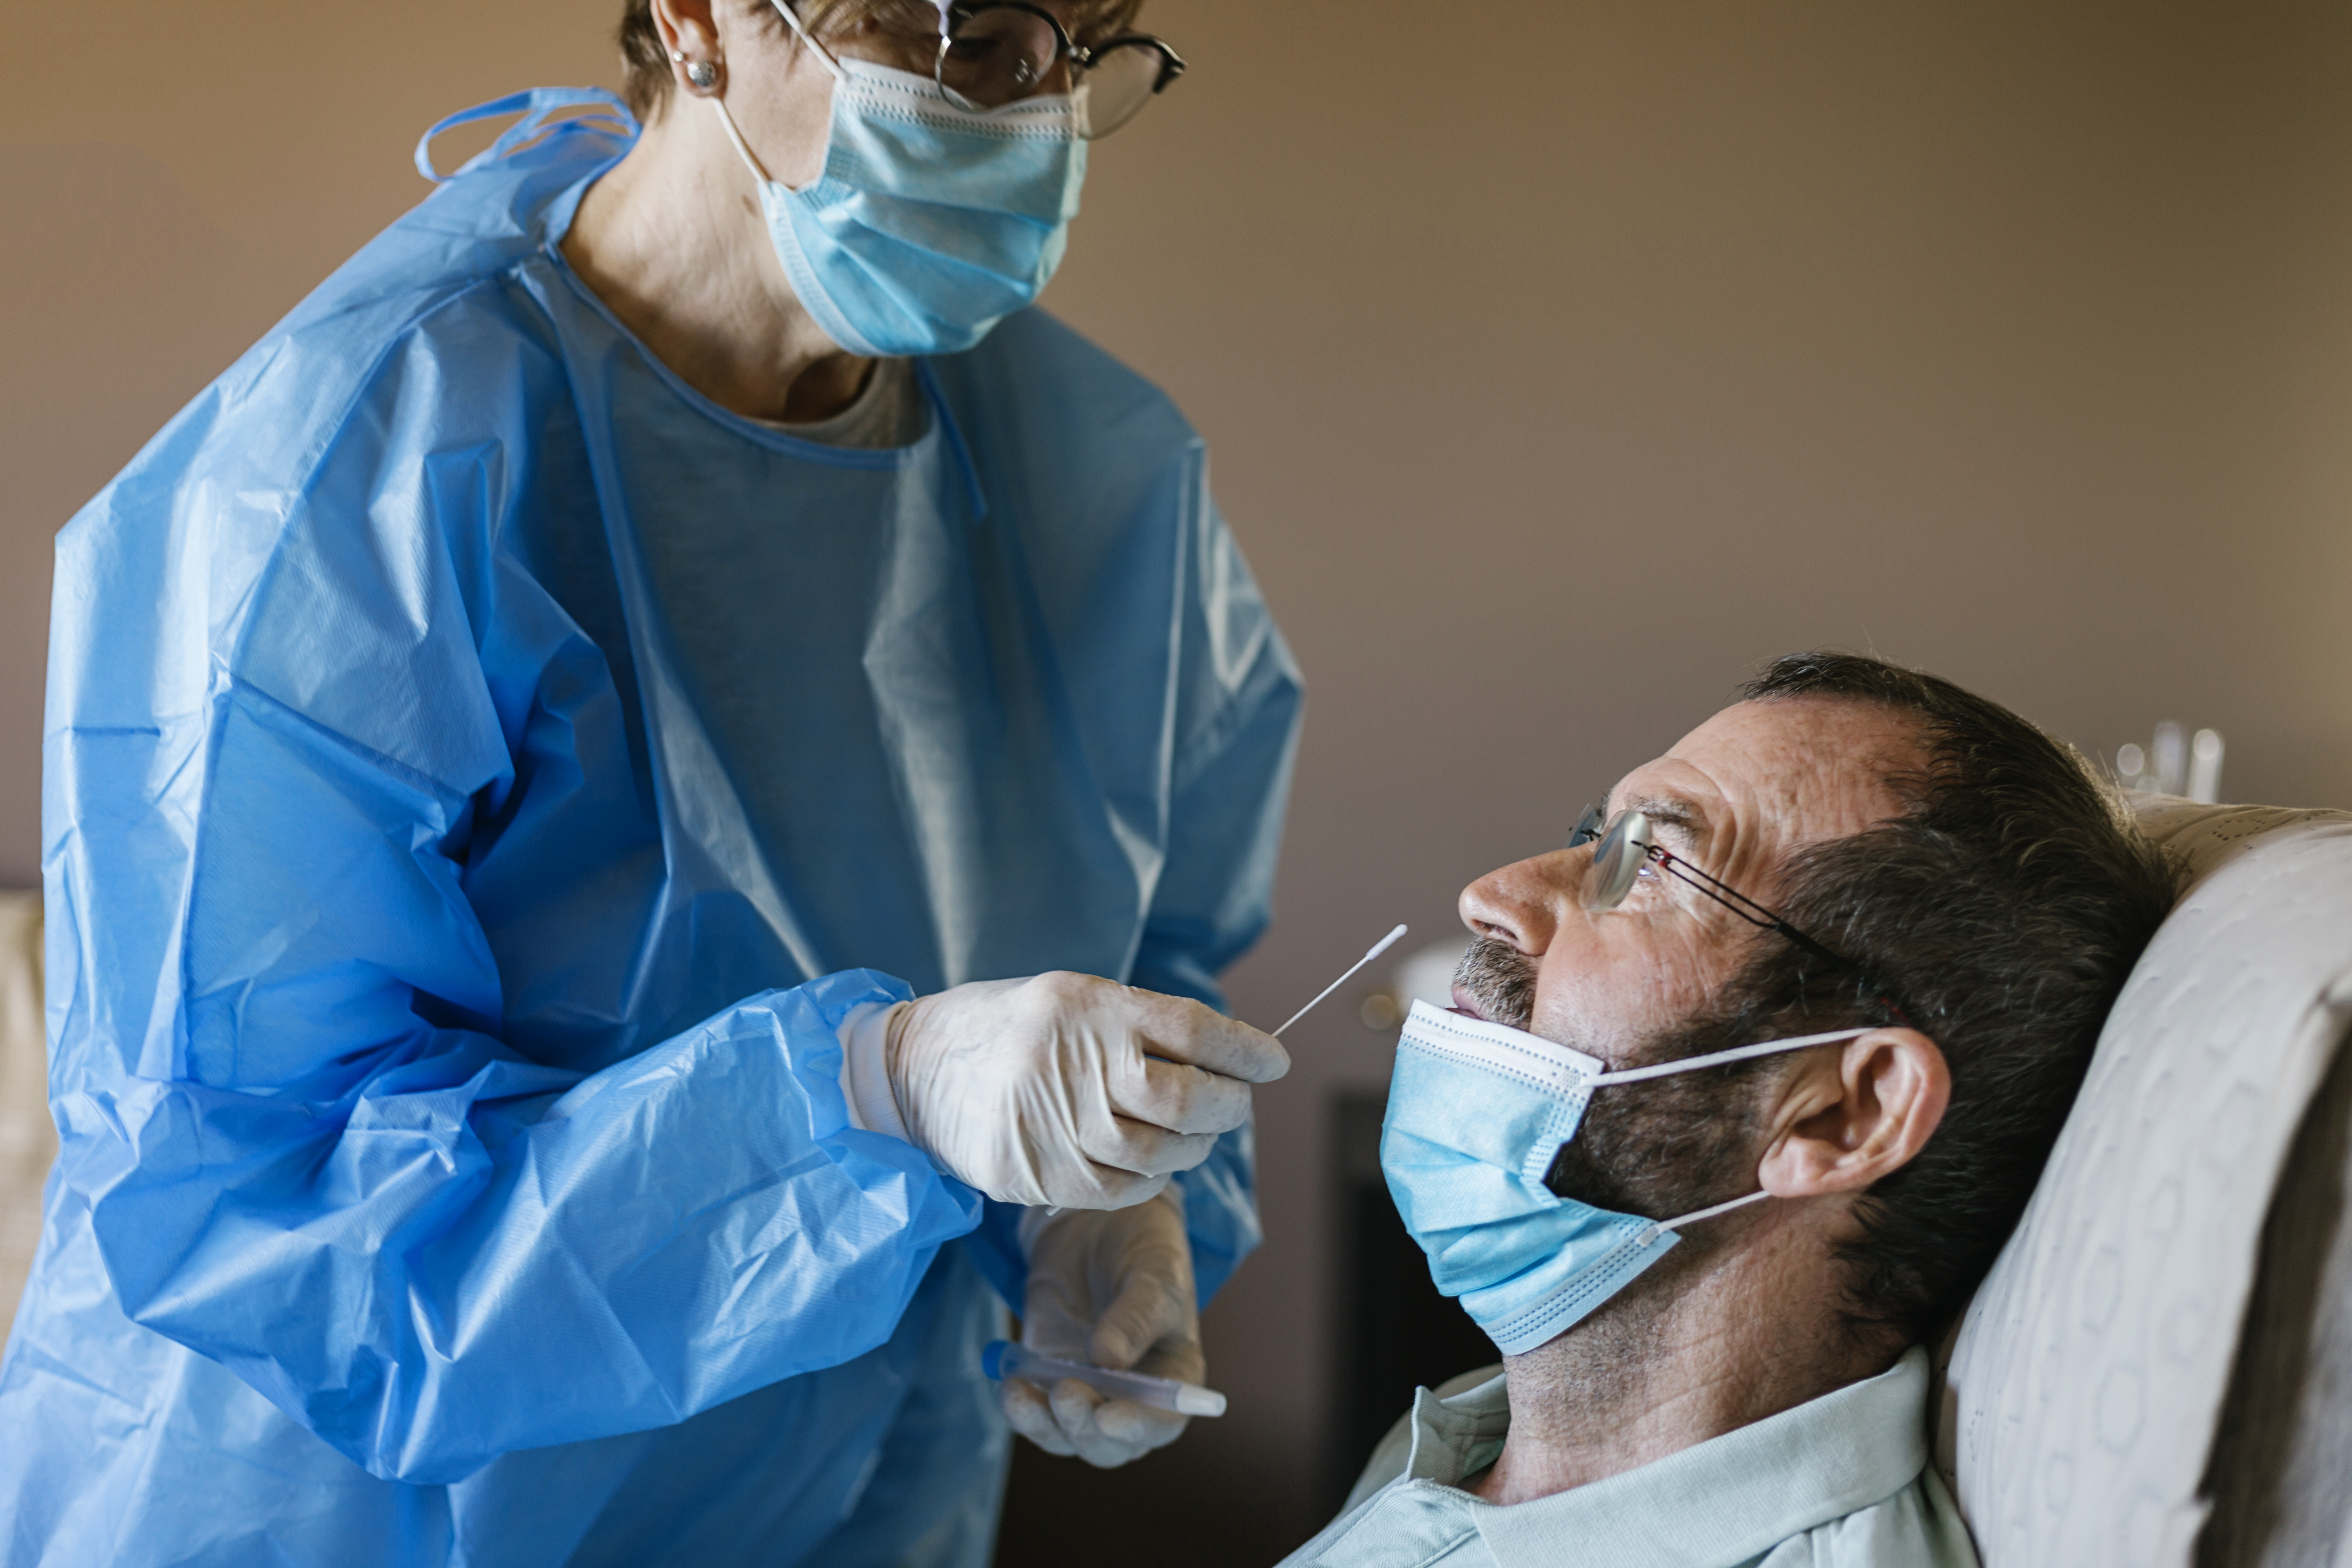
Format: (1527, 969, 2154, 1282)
(1402, 1347, 1929, 1568)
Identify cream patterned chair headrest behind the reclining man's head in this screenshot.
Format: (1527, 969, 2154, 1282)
(1936, 797, 2352, 1568)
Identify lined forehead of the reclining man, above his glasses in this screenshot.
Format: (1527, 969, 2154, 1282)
(1609, 698, 1922, 842)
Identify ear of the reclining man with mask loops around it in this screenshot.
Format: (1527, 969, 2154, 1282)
(1757, 1030, 1952, 1199)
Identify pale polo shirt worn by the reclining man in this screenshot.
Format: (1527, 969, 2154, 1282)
(1284, 1347, 1976, 1568)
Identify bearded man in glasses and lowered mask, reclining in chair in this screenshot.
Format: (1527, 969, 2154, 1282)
(1289, 653, 2176, 1568)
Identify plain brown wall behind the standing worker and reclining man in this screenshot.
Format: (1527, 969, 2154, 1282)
(0, 0, 2352, 1561)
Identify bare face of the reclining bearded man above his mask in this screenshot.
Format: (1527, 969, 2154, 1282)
(1454, 698, 1924, 1067)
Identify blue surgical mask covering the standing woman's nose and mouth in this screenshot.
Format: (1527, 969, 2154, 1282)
(710, 0, 1087, 355)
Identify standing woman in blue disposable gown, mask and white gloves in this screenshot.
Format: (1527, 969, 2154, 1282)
(0, 0, 1298, 1568)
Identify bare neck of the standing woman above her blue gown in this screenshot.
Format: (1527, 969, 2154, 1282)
(562, 94, 873, 423)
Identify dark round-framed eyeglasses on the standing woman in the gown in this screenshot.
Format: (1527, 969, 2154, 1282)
(931, 0, 1183, 139)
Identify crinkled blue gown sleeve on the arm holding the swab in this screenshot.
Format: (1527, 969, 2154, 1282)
(45, 339, 981, 1483)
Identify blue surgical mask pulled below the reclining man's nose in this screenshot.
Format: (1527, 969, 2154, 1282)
(1381, 1002, 1867, 1356)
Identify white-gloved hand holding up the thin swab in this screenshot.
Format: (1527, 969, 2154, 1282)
(849, 973, 1291, 1208)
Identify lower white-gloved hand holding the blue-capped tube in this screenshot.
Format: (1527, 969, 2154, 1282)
(997, 1185, 1209, 1469)
